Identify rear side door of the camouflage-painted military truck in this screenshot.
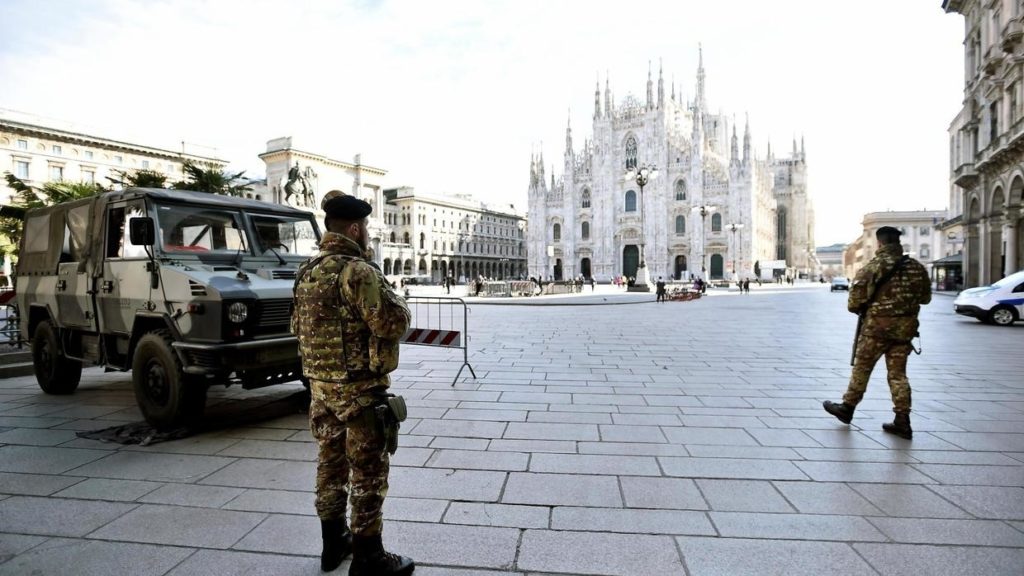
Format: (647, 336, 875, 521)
(54, 203, 96, 332)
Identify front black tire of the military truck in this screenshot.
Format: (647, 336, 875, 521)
(131, 330, 207, 430)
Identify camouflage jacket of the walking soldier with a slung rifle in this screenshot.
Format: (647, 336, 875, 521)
(847, 244, 932, 340)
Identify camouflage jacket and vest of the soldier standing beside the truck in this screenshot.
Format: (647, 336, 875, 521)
(292, 232, 411, 399)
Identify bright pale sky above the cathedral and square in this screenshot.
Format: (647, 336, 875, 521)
(0, 0, 964, 245)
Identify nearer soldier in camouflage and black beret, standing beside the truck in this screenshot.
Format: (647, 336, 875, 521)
(292, 191, 415, 576)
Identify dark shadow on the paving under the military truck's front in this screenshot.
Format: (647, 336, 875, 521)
(78, 389, 309, 446)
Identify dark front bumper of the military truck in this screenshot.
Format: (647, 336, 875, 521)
(173, 336, 301, 375)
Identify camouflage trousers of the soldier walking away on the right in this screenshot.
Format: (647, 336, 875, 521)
(843, 334, 913, 414)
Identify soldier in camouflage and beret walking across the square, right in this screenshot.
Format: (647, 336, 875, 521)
(823, 227, 932, 439)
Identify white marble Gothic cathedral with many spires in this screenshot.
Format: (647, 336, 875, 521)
(527, 52, 814, 281)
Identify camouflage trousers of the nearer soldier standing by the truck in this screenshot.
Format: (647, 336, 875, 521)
(309, 380, 390, 536)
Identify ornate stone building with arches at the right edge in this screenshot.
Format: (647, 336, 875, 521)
(942, 0, 1024, 287)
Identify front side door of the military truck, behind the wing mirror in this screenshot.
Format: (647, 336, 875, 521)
(95, 200, 153, 335)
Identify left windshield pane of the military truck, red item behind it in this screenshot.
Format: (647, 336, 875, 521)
(157, 204, 250, 255)
